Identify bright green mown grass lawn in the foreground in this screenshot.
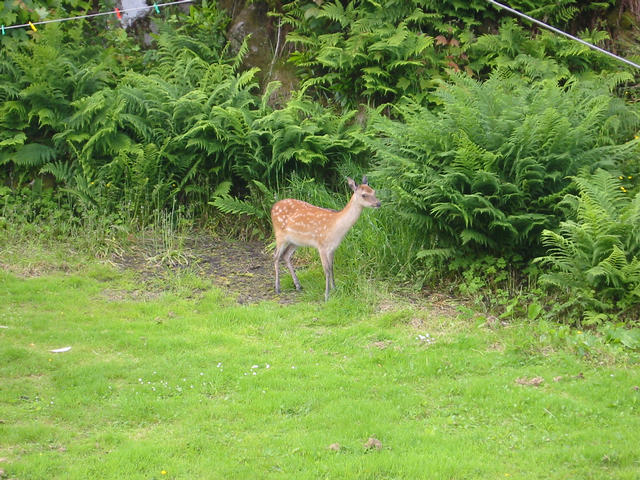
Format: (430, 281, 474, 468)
(0, 253, 640, 479)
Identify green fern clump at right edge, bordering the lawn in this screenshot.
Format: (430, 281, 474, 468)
(537, 170, 640, 324)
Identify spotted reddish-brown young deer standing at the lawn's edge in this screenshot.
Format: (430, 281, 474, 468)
(271, 175, 380, 302)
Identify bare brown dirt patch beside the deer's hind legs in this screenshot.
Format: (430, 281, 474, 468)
(109, 236, 297, 304)
